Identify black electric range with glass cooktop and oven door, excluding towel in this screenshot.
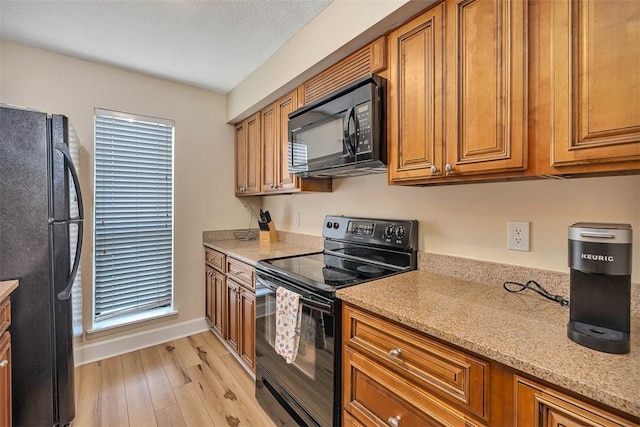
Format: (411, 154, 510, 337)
(256, 216, 418, 426)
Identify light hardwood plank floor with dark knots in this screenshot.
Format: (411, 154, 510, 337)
(71, 332, 275, 427)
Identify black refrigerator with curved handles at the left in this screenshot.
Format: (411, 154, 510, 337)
(0, 106, 83, 426)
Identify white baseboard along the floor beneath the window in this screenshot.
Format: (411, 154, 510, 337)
(73, 317, 209, 366)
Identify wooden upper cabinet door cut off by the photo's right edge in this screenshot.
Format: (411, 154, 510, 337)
(543, 0, 640, 168)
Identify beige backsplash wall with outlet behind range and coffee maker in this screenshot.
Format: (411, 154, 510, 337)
(262, 175, 640, 282)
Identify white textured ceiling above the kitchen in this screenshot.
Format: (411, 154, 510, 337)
(0, 0, 332, 94)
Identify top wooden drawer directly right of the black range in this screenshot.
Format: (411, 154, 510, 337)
(343, 305, 490, 420)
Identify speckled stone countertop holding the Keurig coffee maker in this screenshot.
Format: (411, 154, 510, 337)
(337, 271, 640, 416)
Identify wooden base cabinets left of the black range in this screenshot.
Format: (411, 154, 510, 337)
(205, 247, 256, 373)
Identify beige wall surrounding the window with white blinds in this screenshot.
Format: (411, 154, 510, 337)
(0, 42, 250, 341)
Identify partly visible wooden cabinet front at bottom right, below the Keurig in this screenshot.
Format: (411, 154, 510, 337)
(515, 376, 637, 427)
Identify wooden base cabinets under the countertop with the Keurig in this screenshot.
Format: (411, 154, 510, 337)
(342, 303, 639, 427)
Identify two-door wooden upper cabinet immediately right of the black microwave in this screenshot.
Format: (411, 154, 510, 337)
(388, 0, 528, 183)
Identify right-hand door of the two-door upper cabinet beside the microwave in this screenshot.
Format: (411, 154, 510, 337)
(445, 0, 528, 175)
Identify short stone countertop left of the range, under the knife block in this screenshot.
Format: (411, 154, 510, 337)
(203, 240, 322, 265)
